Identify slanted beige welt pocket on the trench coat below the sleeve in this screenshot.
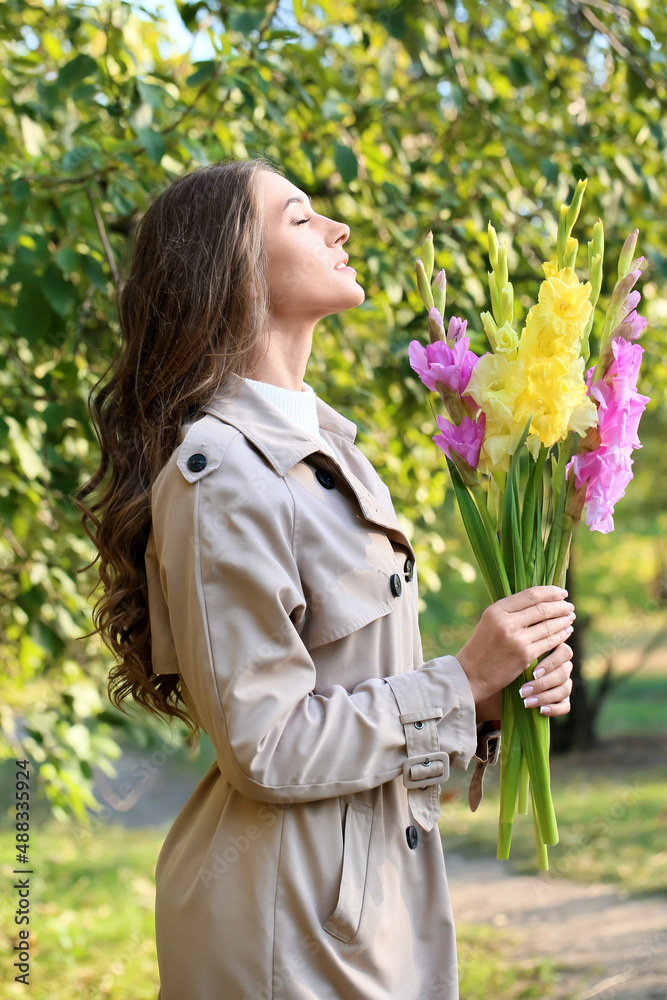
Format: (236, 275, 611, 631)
(323, 803, 373, 942)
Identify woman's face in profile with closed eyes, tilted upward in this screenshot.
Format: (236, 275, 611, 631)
(257, 170, 365, 323)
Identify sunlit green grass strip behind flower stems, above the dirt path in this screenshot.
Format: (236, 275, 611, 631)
(440, 758, 667, 894)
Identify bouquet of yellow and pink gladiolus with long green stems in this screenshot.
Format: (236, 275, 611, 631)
(409, 181, 648, 870)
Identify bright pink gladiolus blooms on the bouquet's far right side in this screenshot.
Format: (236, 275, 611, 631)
(566, 337, 649, 533)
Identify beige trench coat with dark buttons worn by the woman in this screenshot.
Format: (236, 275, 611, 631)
(146, 376, 490, 1000)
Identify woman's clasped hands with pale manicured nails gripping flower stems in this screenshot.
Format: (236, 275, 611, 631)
(456, 586, 576, 722)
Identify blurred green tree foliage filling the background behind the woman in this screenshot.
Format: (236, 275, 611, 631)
(0, 0, 667, 818)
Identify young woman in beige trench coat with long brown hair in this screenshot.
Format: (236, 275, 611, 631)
(77, 158, 574, 1000)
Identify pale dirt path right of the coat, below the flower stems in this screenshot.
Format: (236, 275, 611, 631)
(447, 854, 667, 1000)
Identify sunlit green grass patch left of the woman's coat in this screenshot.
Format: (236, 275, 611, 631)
(0, 820, 164, 1000)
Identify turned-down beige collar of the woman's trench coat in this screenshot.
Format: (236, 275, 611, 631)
(203, 373, 357, 476)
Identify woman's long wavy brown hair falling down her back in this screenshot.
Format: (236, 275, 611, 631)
(71, 156, 280, 744)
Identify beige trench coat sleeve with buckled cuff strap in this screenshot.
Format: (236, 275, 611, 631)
(147, 434, 476, 802)
